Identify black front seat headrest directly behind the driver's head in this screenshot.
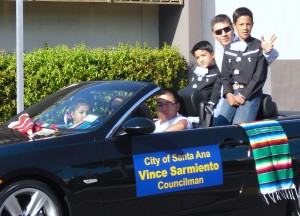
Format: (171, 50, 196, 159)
(178, 88, 204, 116)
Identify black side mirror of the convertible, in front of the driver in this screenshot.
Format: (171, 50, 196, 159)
(122, 117, 155, 134)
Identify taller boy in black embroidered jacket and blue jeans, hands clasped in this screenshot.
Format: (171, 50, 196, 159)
(215, 7, 268, 125)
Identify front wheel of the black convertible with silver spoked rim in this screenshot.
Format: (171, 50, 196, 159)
(0, 180, 62, 216)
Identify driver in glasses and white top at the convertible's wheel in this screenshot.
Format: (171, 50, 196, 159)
(154, 88, 193, 133)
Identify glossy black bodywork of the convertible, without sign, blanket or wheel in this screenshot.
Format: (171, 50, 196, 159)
(0, 81, 300, 216)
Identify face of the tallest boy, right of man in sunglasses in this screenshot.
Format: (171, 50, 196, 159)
(233, 16, 253, 41)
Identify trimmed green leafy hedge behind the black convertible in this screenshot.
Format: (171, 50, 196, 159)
(0, 43, 187, 124)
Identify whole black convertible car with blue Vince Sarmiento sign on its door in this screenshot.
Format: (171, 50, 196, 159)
(0, 81, 300, 216)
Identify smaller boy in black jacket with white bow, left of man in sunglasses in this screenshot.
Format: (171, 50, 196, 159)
(188, 41, 222, 108)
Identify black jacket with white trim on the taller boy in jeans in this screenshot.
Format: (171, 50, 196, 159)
(221, 37, 268, 99)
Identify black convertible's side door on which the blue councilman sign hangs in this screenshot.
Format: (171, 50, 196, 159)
(103, 126, 249, 215)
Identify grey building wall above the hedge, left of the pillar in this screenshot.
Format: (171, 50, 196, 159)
(0, 2, 159, 52)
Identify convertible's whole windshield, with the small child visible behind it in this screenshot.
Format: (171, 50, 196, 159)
(31, 82, 142, 129)
